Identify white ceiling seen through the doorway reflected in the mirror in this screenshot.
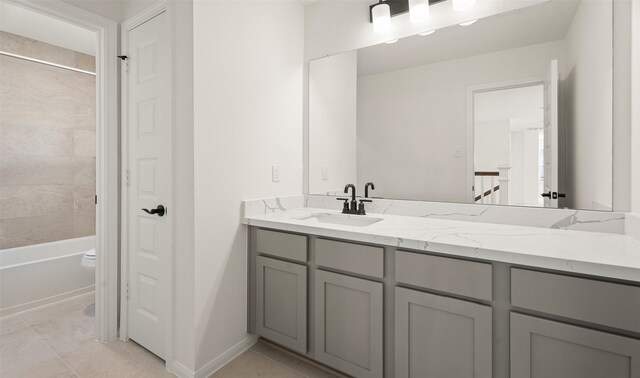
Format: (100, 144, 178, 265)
(473, 85, 544, 131)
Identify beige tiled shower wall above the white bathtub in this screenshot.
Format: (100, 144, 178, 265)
(0, 32, 96, 249)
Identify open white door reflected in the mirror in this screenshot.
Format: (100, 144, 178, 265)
(541, 60, 558, 207)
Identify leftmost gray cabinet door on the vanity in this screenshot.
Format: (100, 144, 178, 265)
(256, 256, 307, 354)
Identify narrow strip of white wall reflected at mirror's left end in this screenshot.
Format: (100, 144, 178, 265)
(309, 51, 358, 193)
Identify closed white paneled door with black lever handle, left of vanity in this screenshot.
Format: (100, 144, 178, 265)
(128, 12, 173, 358)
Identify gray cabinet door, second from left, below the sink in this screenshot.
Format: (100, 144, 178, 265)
(315, 270, 383, 377)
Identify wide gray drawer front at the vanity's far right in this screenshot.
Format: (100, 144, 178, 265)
(511, 268, 640, 332)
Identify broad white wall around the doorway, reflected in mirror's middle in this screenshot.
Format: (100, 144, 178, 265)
(358, 41, 563, 202)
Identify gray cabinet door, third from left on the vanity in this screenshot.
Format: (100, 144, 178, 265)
(395, 287, 492, 378)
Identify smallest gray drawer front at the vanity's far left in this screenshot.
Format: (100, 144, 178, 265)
(256, 230, 307, 262)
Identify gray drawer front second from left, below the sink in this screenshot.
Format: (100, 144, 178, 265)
(316, 239, 384, 278)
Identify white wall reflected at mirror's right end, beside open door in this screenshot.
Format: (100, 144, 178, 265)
(562, 1, 613, 209)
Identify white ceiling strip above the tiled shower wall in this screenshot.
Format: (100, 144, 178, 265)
(0, 1, 96, 56)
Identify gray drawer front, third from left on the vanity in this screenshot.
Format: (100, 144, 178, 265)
(396, 251, 491, 301)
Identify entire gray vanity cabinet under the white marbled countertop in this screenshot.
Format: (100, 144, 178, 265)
(249, 227, 640, 378)
